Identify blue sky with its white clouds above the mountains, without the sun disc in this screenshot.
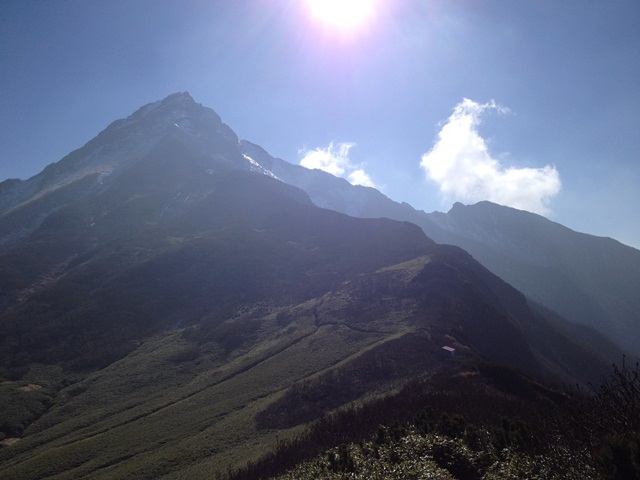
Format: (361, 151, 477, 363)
(0, 0, 640, 248)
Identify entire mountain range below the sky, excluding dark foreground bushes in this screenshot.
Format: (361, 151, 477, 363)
(0, 93, 640, 479)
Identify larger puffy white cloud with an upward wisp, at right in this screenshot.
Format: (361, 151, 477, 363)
(420, 98, 561, 214)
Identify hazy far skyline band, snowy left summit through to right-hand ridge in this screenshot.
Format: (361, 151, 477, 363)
(0, 94, 640, 354)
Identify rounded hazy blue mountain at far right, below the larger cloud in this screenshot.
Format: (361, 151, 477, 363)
(431, 202, 640, 355)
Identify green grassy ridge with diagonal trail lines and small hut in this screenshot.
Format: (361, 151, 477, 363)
(0, 249, 605, 479)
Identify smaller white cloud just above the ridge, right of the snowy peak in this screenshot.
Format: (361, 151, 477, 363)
(300, 142, 375, 187)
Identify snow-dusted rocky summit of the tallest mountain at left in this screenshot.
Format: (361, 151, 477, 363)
(0, 92, 250, 225)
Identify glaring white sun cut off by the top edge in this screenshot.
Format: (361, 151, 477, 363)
(307, 0, 378, 30)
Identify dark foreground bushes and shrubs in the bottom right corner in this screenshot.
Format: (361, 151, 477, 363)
(225, 363, 640, 480)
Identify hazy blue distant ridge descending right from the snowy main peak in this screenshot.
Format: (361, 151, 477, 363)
(242, 141, 640, 355)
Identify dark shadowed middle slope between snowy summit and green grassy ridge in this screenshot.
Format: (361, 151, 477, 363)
(0, 160, 430, 367)
